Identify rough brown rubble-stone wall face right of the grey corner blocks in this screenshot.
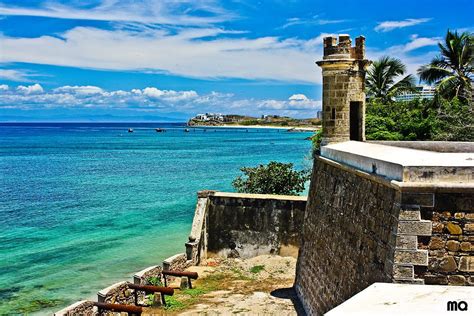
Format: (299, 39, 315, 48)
(412, 192, 474, 286)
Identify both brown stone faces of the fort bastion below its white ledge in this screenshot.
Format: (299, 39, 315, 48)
(295, 157, 474, 315)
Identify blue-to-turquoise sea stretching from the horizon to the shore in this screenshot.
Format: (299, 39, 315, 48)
(0, 123, 311, 315)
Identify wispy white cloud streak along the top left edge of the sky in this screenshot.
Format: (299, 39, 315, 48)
(0, 0, 233, 25)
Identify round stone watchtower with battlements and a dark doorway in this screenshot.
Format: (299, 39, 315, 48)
(316, 34, 370, 145)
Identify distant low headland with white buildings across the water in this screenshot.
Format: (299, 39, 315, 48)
(187, 113, 321, 130)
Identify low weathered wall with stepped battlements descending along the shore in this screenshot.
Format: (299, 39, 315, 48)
(55, 191, 307, 316)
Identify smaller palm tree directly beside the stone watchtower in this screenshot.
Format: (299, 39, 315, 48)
(366, 56, 415, 103)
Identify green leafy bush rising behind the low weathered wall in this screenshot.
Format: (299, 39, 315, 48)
(232, 161, 309, 195)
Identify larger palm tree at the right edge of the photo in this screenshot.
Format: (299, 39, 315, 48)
(418, 30, 474, 100)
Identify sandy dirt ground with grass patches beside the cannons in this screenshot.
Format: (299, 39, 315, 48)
(144, 255, 304, 315)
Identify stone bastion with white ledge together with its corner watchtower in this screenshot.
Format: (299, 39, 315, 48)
(295, 35, 474, 315)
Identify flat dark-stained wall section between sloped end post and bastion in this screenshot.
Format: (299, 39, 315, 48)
(206, 192, 307, 258)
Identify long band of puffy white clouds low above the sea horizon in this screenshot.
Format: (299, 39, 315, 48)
(0, 84, 321, 117)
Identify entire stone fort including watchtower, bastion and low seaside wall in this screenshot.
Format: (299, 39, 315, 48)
(57, 35, 474, 315)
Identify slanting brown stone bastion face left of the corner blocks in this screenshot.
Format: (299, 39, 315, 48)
(295, 158, 400, 315)
